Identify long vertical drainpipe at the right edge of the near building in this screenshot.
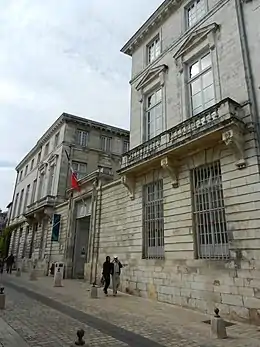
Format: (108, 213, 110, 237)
(235, 0, 260, 169)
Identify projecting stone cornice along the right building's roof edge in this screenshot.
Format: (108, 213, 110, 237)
(120, 0, 178, 56)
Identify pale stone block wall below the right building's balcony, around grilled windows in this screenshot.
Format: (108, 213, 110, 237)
(99, 141, 260, 324)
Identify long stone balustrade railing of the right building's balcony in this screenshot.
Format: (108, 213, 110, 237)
(119, 98, 243, 172)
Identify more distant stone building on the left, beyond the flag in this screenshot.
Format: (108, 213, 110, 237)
(9, 113, 129, 271)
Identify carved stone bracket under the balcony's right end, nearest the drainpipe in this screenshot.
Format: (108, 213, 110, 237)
(222, 128, 246, 169)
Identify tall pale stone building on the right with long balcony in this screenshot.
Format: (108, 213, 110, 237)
(84, 0, 260, 324)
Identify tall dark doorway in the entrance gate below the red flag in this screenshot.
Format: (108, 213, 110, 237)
(73, 216, 90, 279)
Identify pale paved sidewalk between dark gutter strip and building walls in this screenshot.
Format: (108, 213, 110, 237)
(5, 274, 260, 347)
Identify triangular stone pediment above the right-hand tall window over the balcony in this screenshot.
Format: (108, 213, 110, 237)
(173, 23, 219, 60)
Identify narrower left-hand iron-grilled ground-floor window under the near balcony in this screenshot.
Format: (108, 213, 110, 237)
(143, 179, 164, 259)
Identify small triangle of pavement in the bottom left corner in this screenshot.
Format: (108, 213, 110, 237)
(0, 318, 29, 347)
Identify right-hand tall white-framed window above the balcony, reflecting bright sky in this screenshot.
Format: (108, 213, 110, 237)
(188, 53, 215, 115)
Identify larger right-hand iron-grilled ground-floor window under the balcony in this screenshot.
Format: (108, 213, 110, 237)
(192, 161, 229, 259)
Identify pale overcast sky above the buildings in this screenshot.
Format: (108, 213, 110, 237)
(0, 0, 162, 209)
